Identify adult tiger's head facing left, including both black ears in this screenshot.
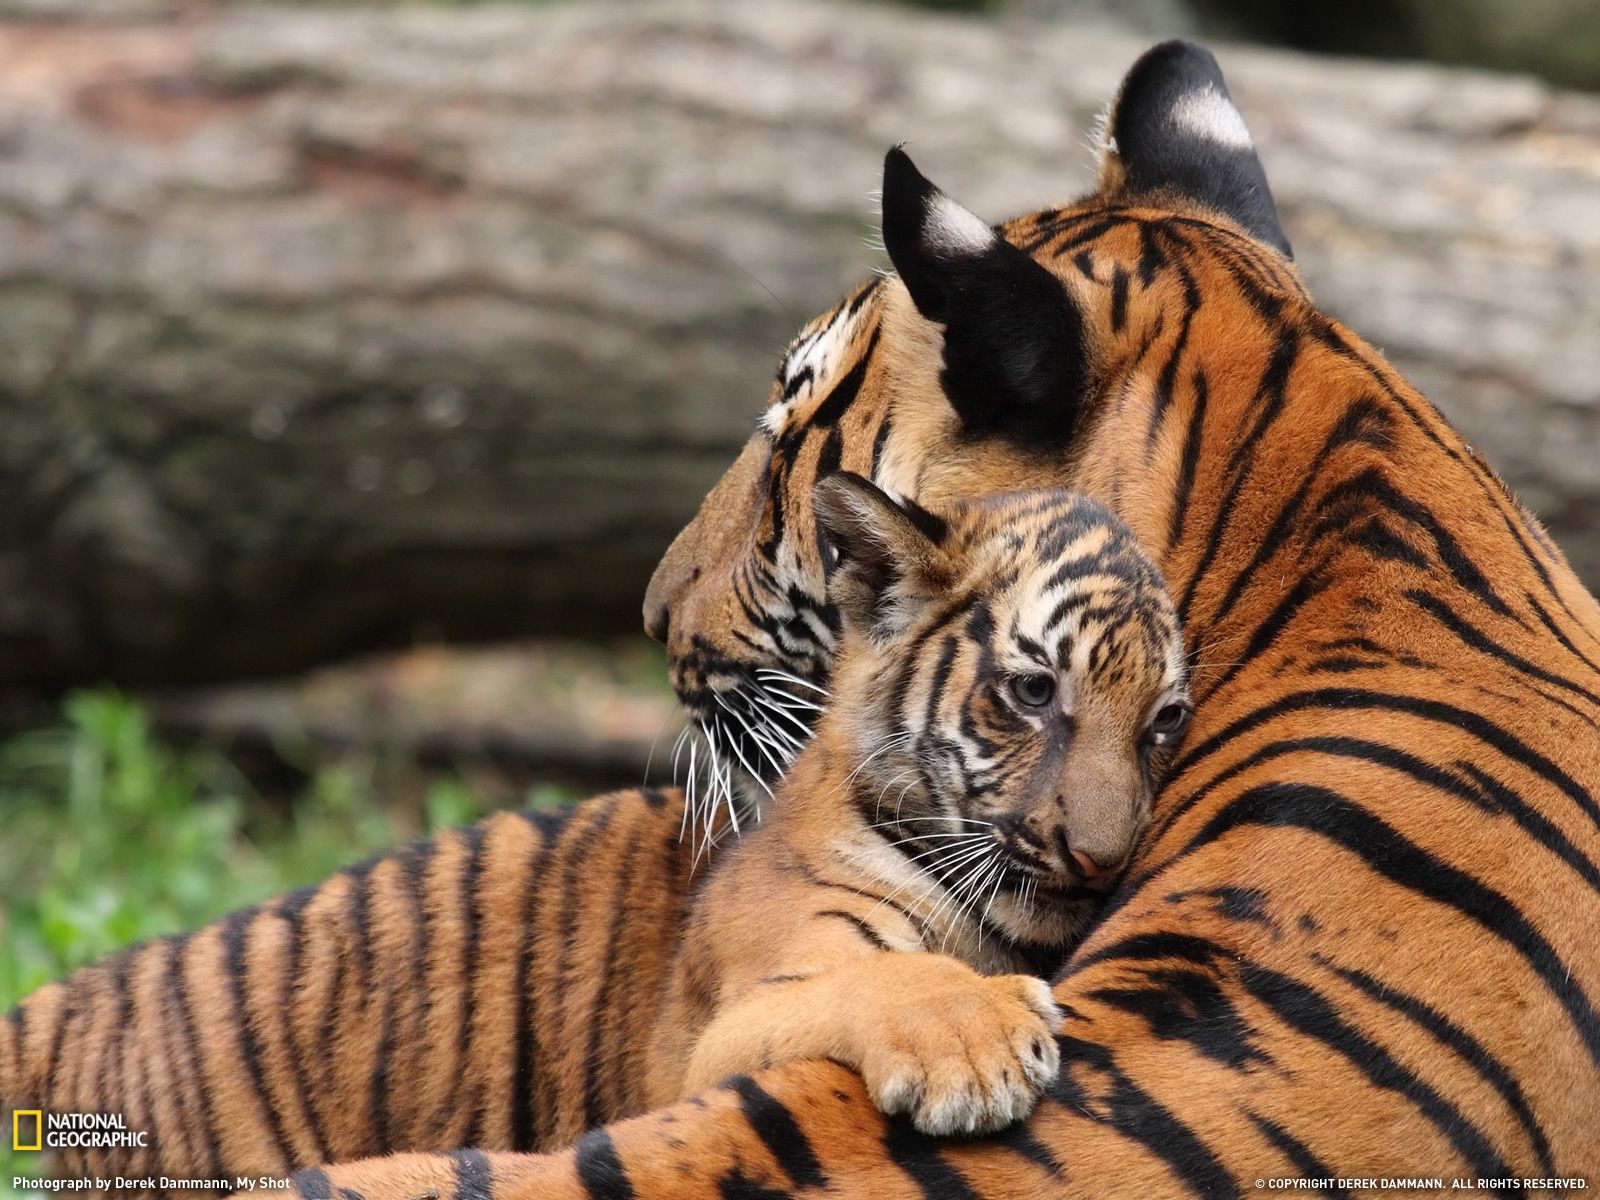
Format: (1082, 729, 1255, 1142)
(645, 42, 1304, 825)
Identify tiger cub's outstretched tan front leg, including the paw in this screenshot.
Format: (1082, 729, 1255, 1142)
(685, 950, 1061, 1134)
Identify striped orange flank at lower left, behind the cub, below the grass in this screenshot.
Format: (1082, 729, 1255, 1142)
(0, 789, 691, 1181)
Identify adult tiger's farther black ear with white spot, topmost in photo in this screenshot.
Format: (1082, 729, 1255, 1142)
(1101, 42, 1294, 258)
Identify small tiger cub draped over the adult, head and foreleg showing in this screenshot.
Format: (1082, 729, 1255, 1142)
(648, 474, 1190, 1134)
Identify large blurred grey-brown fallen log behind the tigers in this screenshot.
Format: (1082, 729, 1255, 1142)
(0, 0, 1600, 688)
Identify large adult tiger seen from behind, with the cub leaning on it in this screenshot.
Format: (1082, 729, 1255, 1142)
(288, 43, 1600, 1200)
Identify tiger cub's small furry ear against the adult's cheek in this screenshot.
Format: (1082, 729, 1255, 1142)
(811, 470, 954, 640)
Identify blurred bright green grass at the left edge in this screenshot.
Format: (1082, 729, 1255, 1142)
(0, 693, 571, 1197)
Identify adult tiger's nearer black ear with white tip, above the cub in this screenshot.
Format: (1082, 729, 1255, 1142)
(883, 147, 1086, 448)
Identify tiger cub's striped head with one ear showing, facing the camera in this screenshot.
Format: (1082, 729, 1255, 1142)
(814, 474, 1189, 941)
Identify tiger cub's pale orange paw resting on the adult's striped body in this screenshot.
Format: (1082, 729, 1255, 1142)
(861, 968, 1061, 1136)
